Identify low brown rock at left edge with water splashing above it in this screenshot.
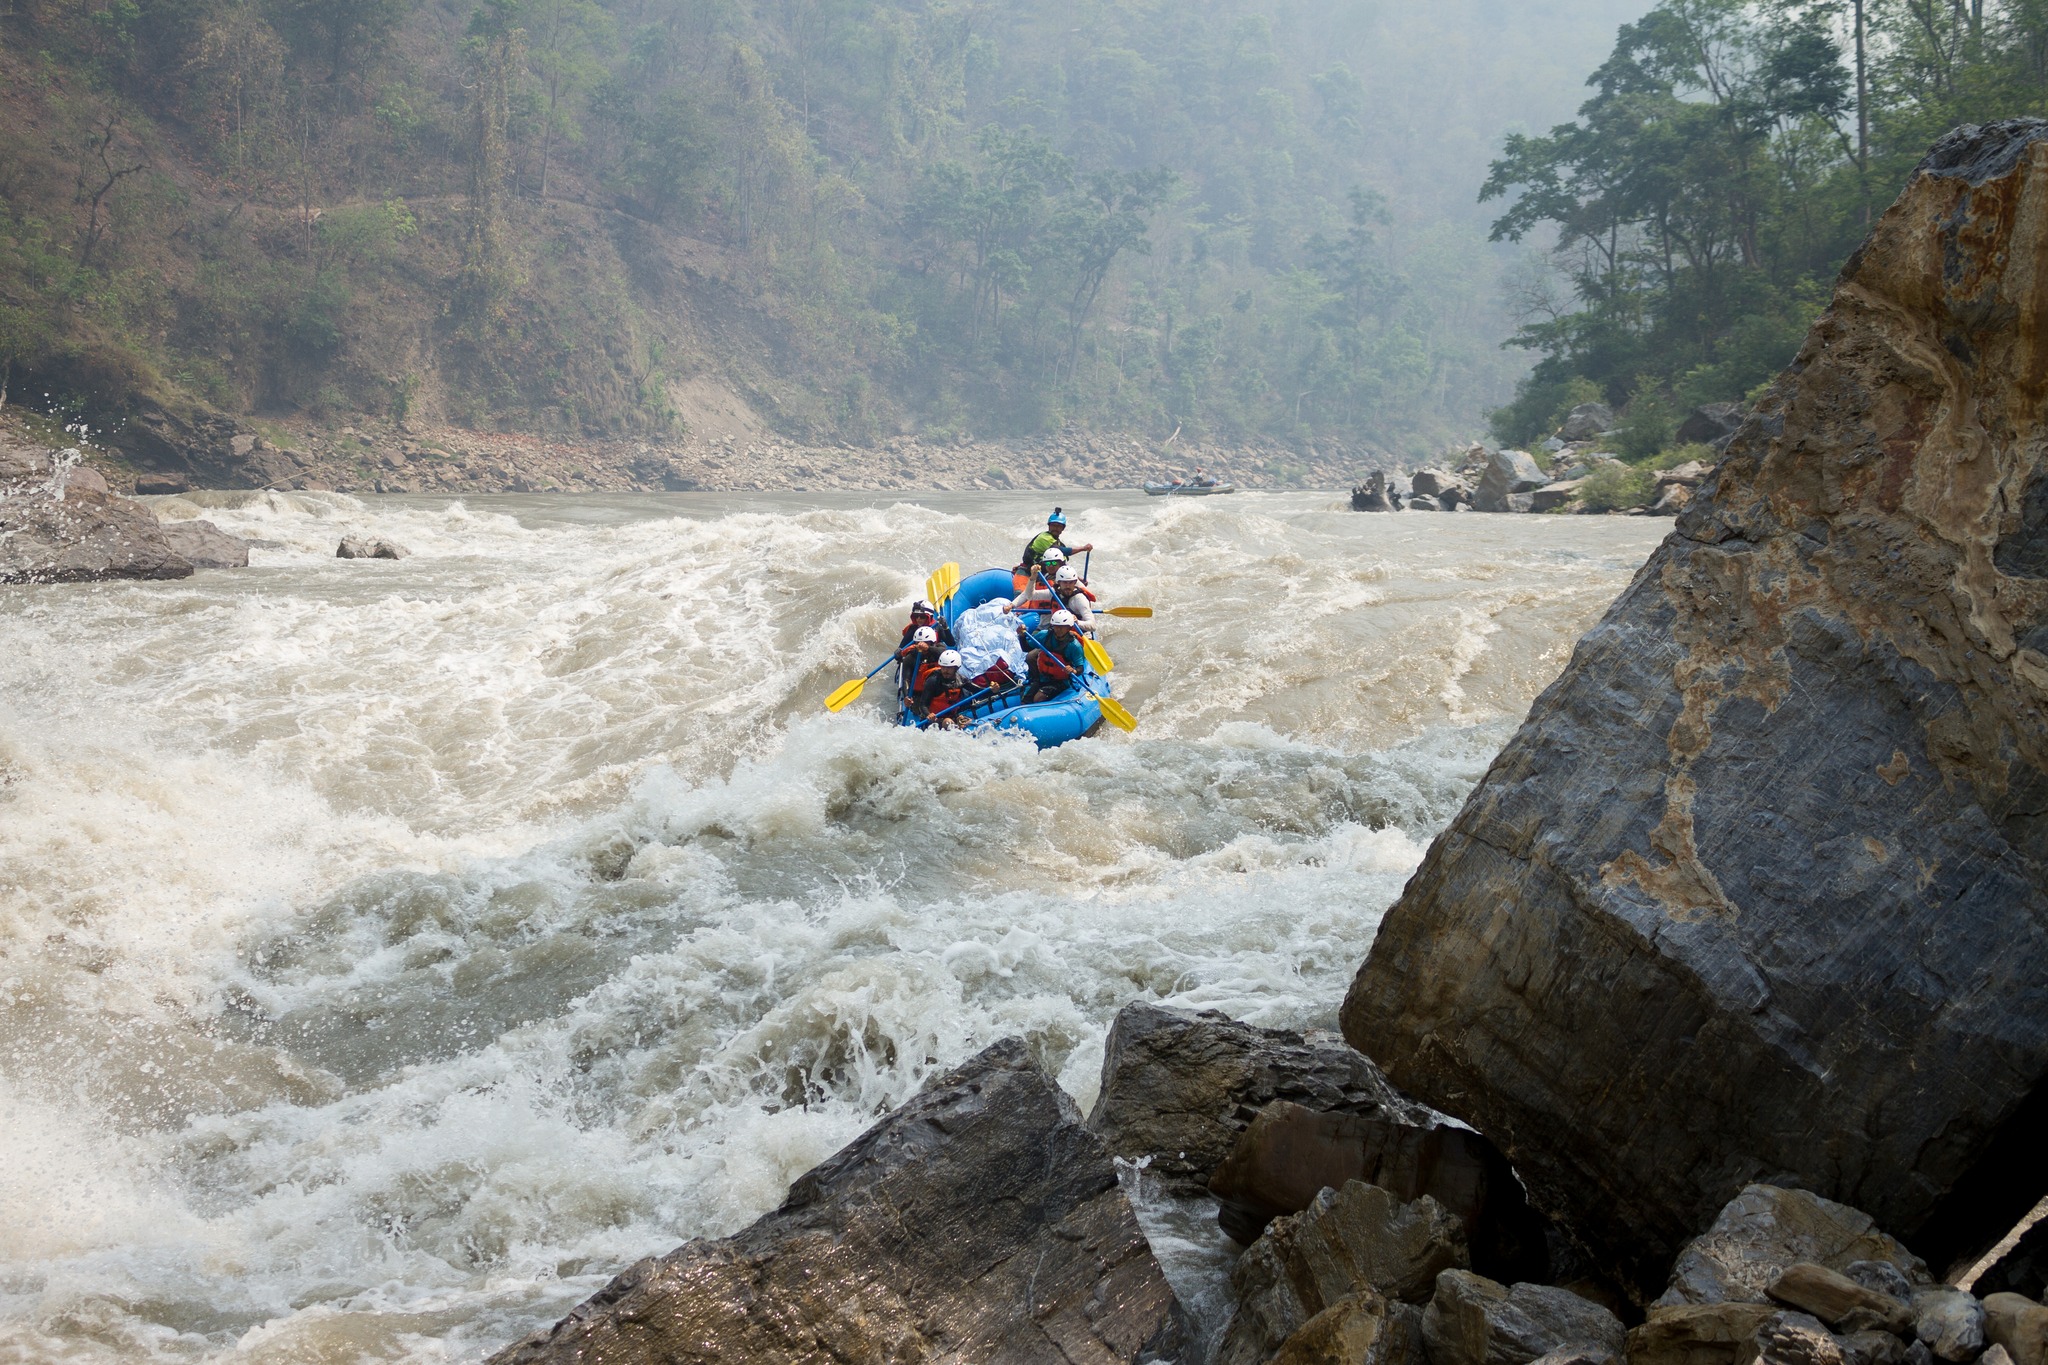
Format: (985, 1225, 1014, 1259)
(0, 438, 193, 583)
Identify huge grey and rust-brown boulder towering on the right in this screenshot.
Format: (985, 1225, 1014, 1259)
(1343, 121, 2048, 1295)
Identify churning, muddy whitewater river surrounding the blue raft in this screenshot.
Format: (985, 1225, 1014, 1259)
(0, 493, 1669, 1363)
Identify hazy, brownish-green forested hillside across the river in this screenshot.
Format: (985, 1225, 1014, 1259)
(0, 0, 1640, 464)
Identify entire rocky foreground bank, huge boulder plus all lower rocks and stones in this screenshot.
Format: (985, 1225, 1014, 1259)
(475, 121, 2048, 1365)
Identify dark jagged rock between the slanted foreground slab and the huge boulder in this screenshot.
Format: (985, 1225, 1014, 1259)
(1087, 1001, 1436, 1212)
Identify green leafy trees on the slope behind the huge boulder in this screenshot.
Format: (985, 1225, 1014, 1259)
(1485, 0, 2048, 454)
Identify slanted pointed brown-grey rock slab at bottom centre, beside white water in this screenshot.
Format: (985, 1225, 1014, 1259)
(494, 1038, 1182, 1365)
